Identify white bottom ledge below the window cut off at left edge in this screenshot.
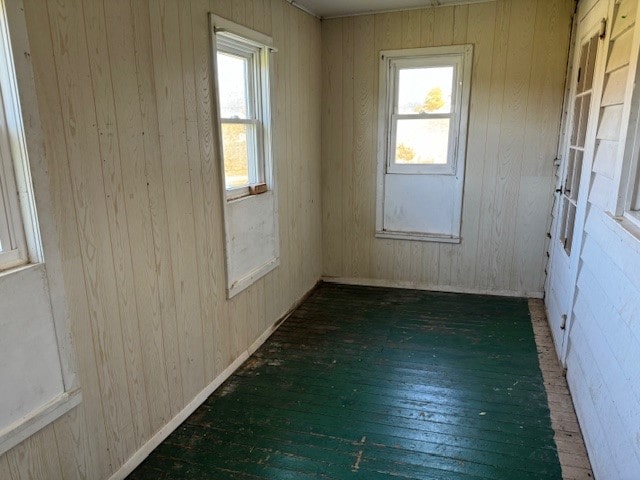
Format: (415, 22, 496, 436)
(0, 388, 82, 455)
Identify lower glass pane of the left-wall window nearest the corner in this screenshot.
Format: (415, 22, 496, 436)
(222, 123, 251, 189)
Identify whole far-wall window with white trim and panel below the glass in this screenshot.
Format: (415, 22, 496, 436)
(376, 45, 473, 243)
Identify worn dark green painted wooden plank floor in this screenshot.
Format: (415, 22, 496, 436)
(129, 284, 561, 480)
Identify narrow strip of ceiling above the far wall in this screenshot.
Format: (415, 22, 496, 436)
(287, 0, 493, 18)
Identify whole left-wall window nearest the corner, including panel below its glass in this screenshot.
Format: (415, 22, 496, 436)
(210, 14, 280, 298)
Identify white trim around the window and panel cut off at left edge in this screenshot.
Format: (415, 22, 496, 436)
(0, 0, 82, 455)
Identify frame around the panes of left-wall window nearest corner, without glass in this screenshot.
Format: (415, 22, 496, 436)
(210, 14, 275, 201)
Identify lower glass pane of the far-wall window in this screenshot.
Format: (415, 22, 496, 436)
(395, 118, 450, 165)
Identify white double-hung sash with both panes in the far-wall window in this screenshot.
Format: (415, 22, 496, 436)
(387, 54, 463, 174)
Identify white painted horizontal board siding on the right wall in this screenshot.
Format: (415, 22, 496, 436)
(547, 0, 640, 480)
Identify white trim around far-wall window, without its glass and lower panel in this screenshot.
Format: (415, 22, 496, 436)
(375, 44, 473, 243)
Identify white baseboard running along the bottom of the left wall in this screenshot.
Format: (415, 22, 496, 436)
(109, 281, 320, 480)
